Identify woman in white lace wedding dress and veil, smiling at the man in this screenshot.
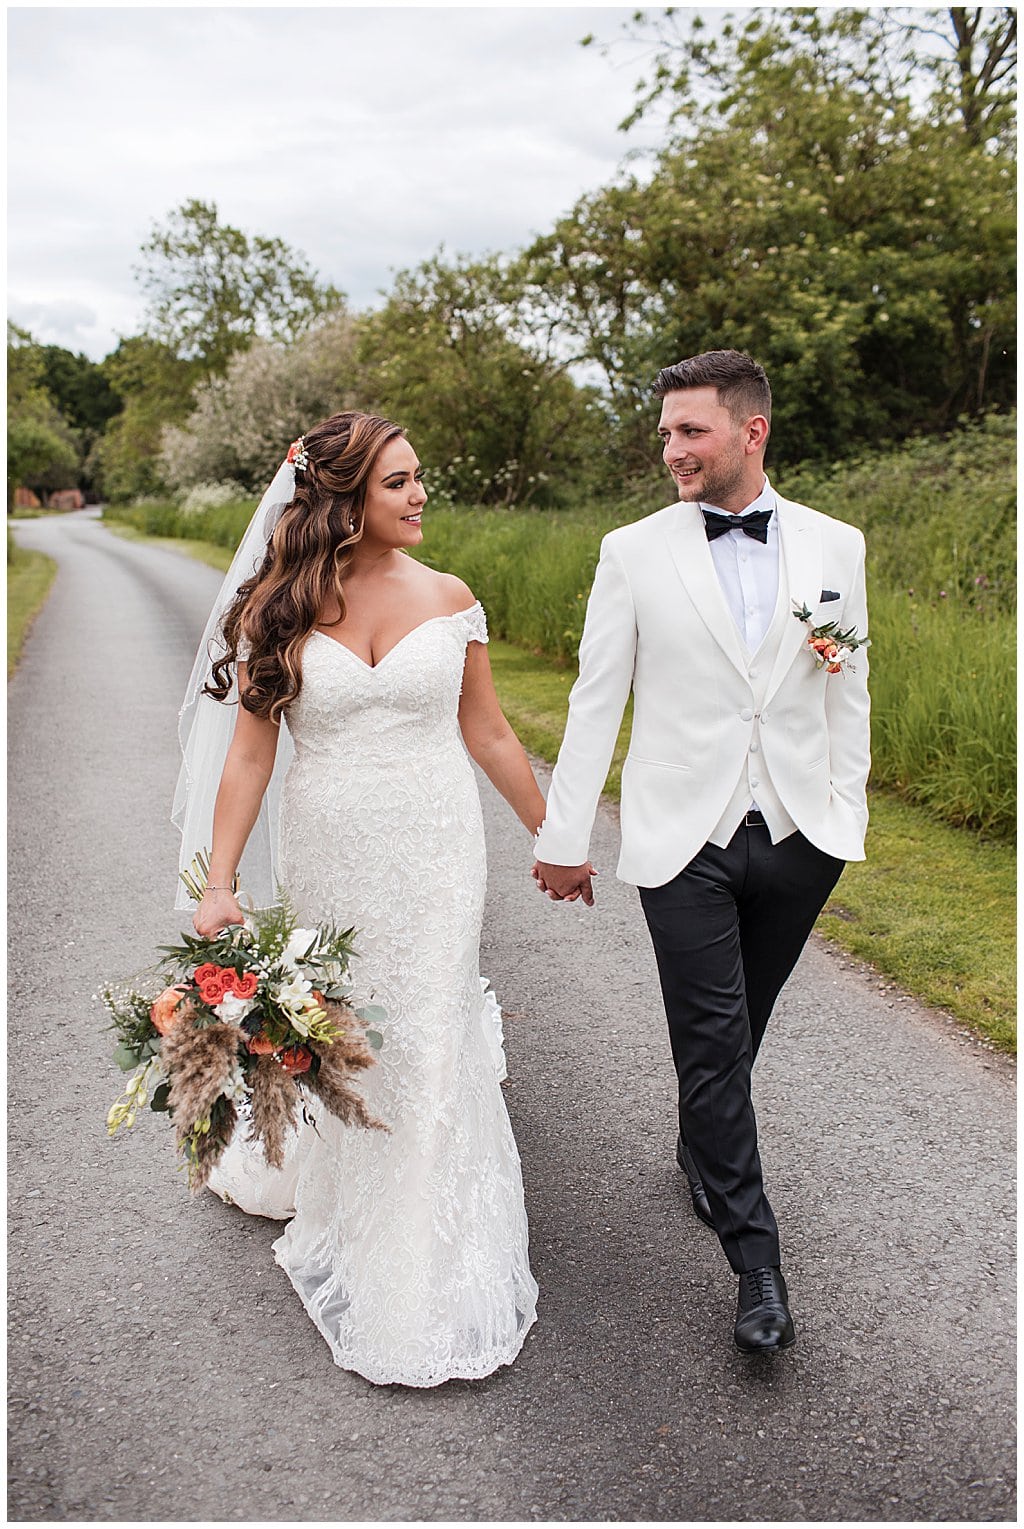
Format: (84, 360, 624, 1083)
(174, 413, 544, 1385)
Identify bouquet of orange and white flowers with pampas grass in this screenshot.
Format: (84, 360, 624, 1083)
(102, 858, 387, 1190)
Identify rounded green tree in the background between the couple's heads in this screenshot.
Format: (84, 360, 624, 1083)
(359, 254, 602, 505)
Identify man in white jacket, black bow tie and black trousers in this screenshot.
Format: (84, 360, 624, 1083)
(533, 350, 870, 1353)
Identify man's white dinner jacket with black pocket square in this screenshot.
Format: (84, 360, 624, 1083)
(536, 495, 870, 887)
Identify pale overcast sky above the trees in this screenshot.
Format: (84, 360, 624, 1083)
(8, 6, 693, 359)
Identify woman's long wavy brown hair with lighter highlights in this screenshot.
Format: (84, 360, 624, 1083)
(203, 411, 405, 722)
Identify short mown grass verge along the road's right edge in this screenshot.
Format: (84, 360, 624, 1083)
(120, 524, 1016, 1052)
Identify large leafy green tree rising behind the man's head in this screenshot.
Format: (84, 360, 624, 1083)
(529, 9, 1015, 462)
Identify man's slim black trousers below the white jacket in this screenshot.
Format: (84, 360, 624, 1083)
(639, 824, 844, 1274)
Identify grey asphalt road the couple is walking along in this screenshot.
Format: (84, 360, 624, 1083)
(8, 514, 1015, 1521)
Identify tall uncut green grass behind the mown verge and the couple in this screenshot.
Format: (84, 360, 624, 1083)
(106, 417, 1016, 838)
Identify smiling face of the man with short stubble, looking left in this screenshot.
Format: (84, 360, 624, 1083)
(657, 387, 763, 514)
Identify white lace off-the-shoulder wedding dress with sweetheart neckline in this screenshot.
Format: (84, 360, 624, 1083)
(211, 604, 536, 1385)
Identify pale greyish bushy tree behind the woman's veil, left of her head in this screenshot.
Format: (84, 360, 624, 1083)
(160, 313, 361, 492)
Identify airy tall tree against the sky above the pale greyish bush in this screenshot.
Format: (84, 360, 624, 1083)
(136, 200, 344, 373)
